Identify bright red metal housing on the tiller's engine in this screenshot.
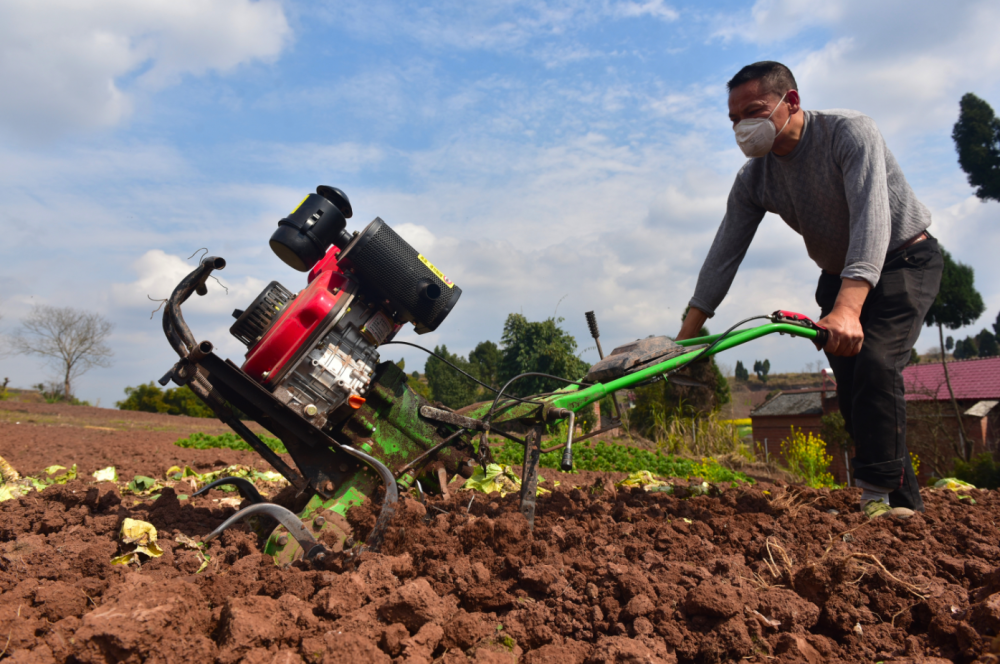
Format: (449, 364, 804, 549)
(243, 266, 347, 385)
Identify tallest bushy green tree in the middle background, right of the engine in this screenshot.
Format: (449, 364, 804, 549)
(497, 314, 590, 396)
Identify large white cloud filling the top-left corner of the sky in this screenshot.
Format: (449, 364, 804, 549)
(0, 0, 290, 139)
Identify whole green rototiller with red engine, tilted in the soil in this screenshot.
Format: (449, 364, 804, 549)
(160, 186, 826, 563)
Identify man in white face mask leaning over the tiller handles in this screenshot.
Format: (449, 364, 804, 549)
(678, 62, 943, 518)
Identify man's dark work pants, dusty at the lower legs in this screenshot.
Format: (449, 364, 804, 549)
(816, 238, 944, 511)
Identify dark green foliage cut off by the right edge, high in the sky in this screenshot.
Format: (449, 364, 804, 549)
(951, 92, 1000, 201)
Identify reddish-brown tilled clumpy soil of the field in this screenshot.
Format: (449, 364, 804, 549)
(0, 402, 1000, 664)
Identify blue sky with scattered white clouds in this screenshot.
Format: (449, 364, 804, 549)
(0, 0, 1000, 406)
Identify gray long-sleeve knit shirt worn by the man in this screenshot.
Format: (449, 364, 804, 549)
(691, 109, 931, 316)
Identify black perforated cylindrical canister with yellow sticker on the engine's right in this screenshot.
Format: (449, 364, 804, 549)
(338, 217, 462, 334)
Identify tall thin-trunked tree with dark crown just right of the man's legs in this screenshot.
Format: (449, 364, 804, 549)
(924, 249, 985, 461)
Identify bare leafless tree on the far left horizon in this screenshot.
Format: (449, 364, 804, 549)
(10, 305, 114, 399)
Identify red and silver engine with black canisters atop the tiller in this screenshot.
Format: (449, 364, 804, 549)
(230, 187, 462, 428)
